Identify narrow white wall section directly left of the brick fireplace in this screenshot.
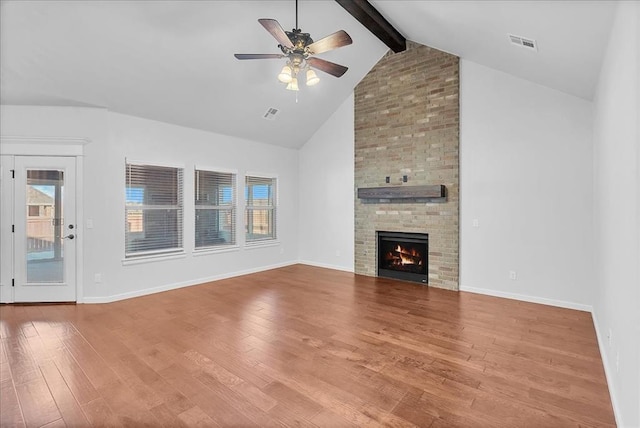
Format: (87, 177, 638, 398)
(298, 95, 355, 272)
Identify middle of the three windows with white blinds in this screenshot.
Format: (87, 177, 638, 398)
(195, 169, 236, 249)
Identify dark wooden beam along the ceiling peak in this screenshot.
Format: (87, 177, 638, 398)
(336, 0, 407, 53)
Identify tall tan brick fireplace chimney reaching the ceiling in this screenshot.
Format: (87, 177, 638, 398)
(355, 42, 459, 290)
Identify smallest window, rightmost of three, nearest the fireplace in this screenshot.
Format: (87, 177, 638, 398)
(244, 176, 277, 242)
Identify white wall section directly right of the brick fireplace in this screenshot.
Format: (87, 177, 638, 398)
(460, 60, 594, 310)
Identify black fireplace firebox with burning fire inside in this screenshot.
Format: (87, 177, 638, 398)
(376, 231, 429, 284)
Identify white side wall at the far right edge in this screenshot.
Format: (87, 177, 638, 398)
(594, 2, 640, 427)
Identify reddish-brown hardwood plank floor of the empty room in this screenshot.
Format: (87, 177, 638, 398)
(0, 265, 615, 428)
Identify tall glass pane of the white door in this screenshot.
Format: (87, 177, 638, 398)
(25, 170, 64, 284)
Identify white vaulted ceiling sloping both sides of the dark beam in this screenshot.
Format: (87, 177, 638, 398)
(0, 0, 616, 147)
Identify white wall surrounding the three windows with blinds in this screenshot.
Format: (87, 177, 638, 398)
(1, 106, 298, 302)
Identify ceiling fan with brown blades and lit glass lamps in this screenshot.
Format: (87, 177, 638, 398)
(234, 0, 352, 91)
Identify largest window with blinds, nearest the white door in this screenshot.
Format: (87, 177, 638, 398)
(125, 163, 183, 258)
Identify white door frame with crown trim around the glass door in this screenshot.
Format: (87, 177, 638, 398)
(0, 135, 91, 303)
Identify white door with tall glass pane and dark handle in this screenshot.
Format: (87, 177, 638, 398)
(13, 156, 78, 302)
